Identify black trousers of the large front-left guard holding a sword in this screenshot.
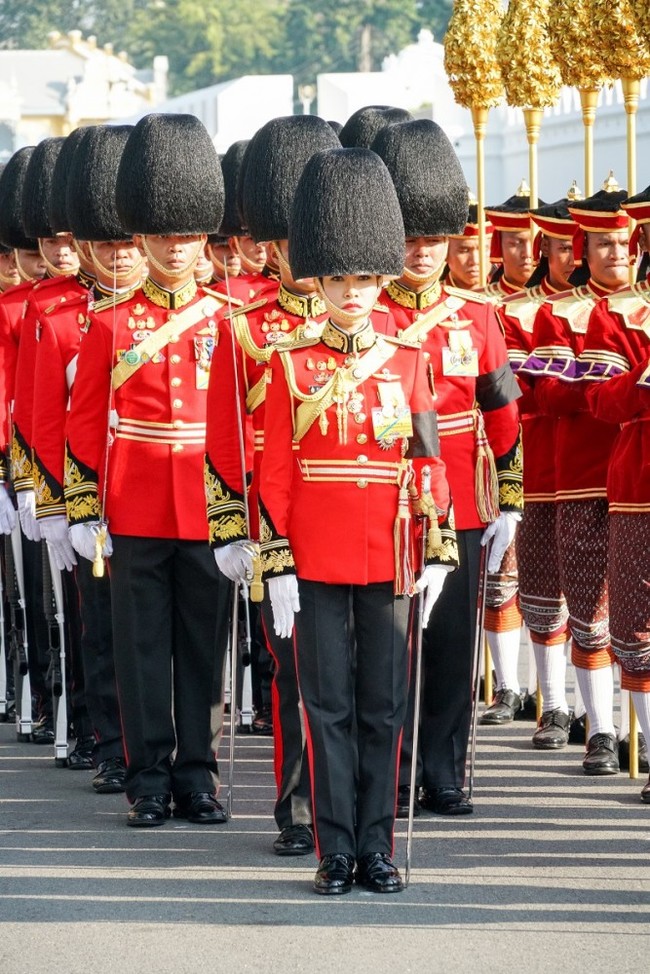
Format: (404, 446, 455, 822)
(110, 535, 231, 801)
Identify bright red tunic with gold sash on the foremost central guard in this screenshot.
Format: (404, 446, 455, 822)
(260, 322, 449, 585)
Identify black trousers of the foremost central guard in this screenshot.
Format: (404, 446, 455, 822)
(296, 579, 409, 857)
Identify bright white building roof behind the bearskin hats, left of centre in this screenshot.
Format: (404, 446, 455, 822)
(120, 74, 293, 152)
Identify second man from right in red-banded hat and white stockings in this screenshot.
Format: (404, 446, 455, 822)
(520, 189, 629, 775)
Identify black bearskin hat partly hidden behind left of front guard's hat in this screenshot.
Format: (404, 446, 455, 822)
(242, 115, 341, 242)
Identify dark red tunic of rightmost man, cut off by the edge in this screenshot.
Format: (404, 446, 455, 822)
(580, 282, 650, 514)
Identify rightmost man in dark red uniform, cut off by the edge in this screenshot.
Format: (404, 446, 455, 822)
(580, 187, 650, 803)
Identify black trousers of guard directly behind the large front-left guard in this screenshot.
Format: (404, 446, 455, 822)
(75, 558, 124, 765)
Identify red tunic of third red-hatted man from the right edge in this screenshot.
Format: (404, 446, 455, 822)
(496, 278, 558, 504)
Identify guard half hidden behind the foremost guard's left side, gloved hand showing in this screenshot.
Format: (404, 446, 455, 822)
(206, 115, 339, 855)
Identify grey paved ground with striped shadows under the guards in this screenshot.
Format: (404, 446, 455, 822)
(0, 700, 650, 974)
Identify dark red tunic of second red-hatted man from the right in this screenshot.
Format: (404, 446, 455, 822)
(521, 281, 616, 501)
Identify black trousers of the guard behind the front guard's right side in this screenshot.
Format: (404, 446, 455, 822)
(399, 528, 483, 790)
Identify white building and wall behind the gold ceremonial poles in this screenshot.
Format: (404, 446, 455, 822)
(316, 30, 650, 204)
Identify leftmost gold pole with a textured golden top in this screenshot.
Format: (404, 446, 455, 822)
(444, 0, 503, 283)
